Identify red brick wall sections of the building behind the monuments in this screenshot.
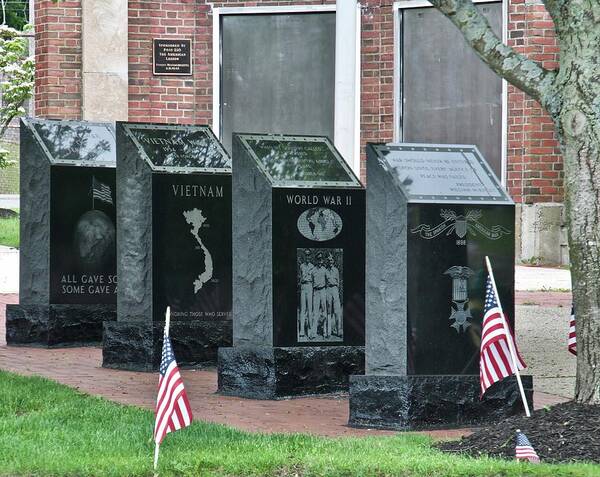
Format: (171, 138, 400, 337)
(35, 0, 563, 203)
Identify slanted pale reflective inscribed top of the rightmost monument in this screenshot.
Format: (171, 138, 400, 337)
(373, 143, 512, 203)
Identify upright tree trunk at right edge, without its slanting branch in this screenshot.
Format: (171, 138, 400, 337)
(545, 4, 600, 404)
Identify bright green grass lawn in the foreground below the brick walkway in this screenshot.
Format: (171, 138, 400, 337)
(0, 372, 600, 477)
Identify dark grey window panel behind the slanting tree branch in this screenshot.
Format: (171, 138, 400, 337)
(400, 3, 502, 177)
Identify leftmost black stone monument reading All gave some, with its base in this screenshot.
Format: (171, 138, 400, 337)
(6, 118, 117, 346)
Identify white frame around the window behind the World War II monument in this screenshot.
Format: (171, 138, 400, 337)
(212, 0, 361, 176)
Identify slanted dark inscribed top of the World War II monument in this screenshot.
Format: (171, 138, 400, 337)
(237, 134, 361, 188)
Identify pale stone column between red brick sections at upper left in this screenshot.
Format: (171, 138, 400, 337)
(81, 0, 129, 122)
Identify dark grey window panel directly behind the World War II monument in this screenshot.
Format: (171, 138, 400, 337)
(220, 13, 335, 152)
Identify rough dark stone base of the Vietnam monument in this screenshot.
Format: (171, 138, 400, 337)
(102, 320, 233, 371)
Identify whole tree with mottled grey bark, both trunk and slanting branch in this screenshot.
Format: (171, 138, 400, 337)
(430, 0, 600, 404)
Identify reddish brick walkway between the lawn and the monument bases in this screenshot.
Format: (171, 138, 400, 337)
(0, 294, 566, 438)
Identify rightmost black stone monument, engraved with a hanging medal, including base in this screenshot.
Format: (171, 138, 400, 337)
(349, 144, 533, 429)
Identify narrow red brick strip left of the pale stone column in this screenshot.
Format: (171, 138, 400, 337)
(34, 0, 81, 119)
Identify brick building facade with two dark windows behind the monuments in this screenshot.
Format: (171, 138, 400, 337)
(34, 0, 568, 264)
